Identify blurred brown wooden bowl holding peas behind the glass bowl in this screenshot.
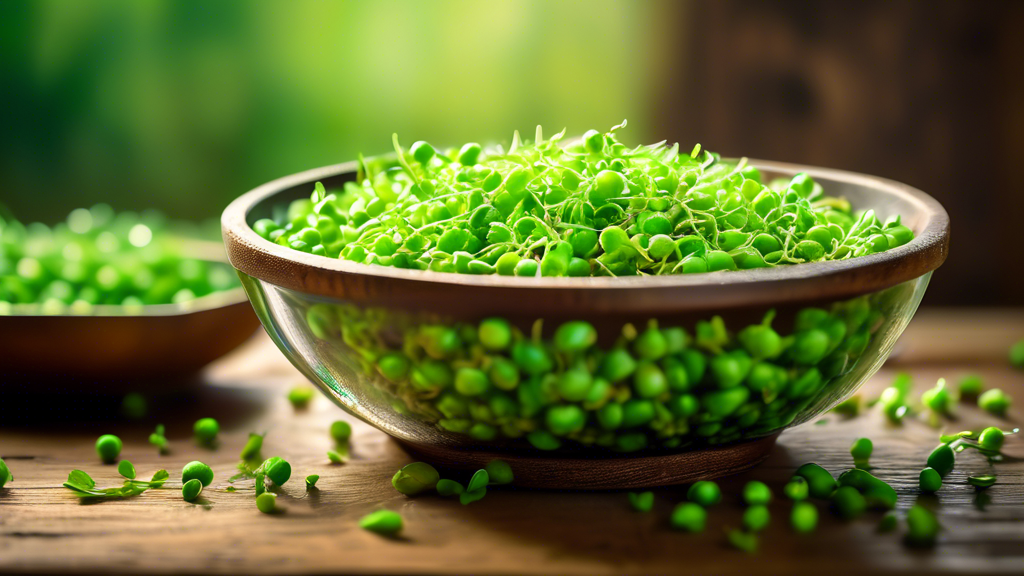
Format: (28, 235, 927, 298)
(0, 288, 259, 393)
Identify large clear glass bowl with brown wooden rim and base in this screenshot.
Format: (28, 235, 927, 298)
(222, 156, 949, 488)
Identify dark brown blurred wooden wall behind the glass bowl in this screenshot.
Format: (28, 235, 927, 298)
(654, 0, 1024, 305)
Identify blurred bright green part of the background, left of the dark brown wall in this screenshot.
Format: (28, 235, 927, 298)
(0, 0, 659, 222)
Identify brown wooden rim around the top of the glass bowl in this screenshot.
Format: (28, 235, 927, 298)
(221, 160, 949, 312)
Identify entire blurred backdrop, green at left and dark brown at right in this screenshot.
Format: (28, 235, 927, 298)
(6, 0, 1024, 305)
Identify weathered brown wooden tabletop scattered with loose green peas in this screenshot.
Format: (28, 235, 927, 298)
(0, 311, 1024, 575)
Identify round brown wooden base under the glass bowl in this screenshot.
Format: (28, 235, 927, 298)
(396, 433, 778, 490)
